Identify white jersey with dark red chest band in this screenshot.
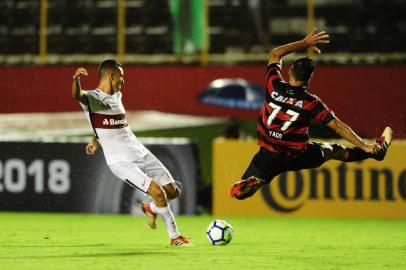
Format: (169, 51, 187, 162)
(80, 89, 149, 165)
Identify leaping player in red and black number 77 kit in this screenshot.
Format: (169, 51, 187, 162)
(230, 29, 392, 200)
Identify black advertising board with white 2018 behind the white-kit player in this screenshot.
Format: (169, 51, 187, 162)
(0, 139, 199, 214)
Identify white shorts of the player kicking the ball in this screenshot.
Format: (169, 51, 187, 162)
(109, 152, 175, 193)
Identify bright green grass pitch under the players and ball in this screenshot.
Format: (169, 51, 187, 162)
(0, 213, 406, 270)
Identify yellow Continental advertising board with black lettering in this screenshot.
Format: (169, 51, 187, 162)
(213, 139, 406, 218)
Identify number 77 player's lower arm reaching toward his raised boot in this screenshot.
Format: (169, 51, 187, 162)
(327, 118, 381, 154)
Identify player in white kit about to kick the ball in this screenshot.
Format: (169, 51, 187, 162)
(72, 60, 191, 246)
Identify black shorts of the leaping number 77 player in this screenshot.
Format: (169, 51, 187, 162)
(242, 142, 325, 183)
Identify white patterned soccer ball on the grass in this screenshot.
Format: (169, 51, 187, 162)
(206, 219, 234, 246)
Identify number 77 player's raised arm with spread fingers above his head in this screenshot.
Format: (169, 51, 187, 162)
(268, 28, 330, 65)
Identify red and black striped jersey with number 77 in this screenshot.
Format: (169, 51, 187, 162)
(257, 64, 335, 154)
